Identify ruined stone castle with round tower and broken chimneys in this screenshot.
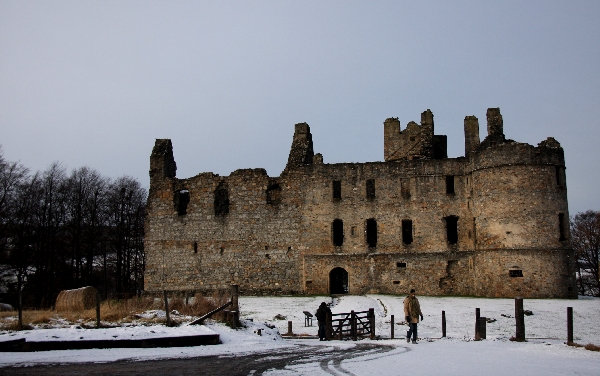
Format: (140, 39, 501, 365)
(145, 108, 577, 298)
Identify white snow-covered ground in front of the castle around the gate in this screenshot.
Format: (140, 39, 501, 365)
(0, 295, 600, 375)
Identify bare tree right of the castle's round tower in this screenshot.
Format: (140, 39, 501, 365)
(571, 210, 600, 296)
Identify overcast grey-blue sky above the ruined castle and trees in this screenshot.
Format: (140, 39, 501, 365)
(0, 0, 600, 214)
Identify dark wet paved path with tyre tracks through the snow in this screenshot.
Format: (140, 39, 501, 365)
(0, 343, 408, 376)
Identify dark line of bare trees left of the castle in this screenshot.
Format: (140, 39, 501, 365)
(0, 148, 147, 308)
